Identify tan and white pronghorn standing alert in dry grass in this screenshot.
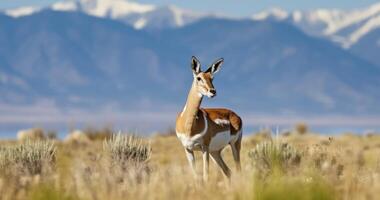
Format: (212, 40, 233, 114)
(176, 56, 242, 181)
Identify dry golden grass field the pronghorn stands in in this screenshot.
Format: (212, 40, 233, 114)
(0, 128, 380, 200)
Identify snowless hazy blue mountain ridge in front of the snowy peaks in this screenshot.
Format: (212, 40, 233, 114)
(0, 10, 380, 114)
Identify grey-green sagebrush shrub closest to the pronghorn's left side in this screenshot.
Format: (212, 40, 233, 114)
(103, 133, 151, 168)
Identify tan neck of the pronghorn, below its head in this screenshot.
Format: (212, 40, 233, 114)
(181, 81, 203, 133)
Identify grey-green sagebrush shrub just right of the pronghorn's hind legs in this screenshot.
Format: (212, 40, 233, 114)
(248, 141, 301, 171)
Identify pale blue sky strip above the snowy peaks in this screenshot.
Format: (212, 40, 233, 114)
(0, 0, 380, 16)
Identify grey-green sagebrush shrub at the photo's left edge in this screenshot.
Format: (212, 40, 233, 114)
(0, 140, 56, 175)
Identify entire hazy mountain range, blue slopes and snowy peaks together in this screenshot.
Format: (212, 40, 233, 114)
(0, 0, 380, 134)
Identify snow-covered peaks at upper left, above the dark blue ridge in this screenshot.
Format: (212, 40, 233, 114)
(4, 0, 207, 29)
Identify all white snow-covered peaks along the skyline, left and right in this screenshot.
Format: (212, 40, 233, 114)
(4, 0, 380, 41)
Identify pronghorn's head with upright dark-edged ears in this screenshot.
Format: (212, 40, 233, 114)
(191, 56, 223, 98)
